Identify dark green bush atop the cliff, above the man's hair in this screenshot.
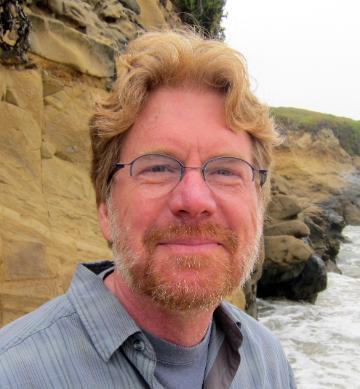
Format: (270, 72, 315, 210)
(173, 0, 226, 39)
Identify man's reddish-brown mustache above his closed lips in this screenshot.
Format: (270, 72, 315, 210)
(143, 223, 238, 255)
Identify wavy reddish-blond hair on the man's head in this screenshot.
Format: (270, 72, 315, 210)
(90, 31, 279, 205)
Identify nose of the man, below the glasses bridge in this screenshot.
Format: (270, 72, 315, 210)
(169, 169, 216, 221)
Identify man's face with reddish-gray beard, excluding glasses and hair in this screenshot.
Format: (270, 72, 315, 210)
(99, 88, 262, 310)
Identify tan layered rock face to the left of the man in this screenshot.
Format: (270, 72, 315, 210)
(0, 0, 179, 326)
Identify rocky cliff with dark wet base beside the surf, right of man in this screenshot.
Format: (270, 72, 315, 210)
(258, 127, 360, 308)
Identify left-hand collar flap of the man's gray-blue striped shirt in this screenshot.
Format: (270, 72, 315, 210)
(67, 261, 140, 361)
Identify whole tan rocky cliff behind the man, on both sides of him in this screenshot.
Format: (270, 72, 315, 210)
(0, 0, 360, 326)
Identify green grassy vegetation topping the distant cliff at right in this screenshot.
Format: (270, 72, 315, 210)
(271, 107, 360, 155)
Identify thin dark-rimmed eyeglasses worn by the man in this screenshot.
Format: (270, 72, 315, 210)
(108, 154, 267, 192)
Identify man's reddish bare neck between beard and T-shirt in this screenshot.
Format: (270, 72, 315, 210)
(105, 272, 215, 347)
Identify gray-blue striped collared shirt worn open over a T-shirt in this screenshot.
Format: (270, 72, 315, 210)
(0, 262, 295, 389)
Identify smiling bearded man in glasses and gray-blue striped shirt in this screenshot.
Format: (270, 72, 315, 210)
(0, 32, 295, 389)
